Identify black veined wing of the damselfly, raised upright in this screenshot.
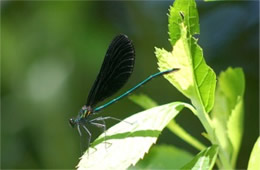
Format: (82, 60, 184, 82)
(86, 35, 135, 107)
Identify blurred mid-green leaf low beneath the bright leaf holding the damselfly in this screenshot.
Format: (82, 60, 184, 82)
(130, 145, 193, 169)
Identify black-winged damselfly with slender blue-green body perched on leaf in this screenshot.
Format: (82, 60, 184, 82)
(69, 34, 178, 145)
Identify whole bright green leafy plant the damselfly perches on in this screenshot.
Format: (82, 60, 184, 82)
(78, 0, 252, 169)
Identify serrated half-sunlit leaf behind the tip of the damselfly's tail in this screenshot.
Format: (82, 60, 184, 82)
(155, 23, 216, 113)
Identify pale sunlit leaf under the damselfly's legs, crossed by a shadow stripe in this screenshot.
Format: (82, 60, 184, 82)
(78, 102, 183, 170)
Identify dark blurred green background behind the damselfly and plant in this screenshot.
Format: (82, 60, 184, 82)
(1, 1, 259, 169)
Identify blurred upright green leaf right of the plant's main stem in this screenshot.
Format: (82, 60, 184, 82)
(211, 68, 245, 167)
